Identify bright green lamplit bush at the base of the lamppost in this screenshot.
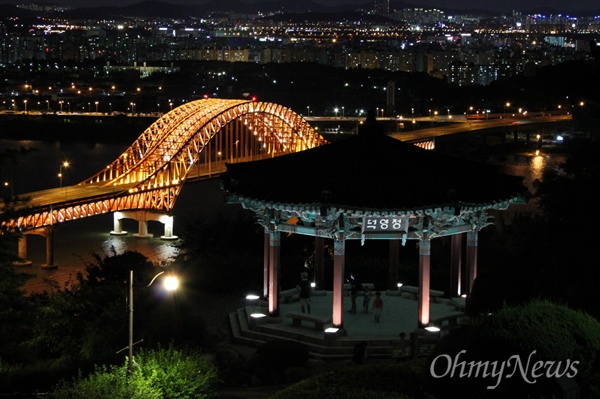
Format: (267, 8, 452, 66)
(49, 348, 218, 399)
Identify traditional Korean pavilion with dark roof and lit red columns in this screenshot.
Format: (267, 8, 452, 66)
(222, 115, 526, 328)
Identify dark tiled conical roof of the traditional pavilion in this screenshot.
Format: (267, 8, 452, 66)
(222, 119, 526, 210)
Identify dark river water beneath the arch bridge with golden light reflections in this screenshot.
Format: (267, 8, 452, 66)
(0, 140, 564, 291)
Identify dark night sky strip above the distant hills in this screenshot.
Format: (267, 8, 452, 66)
(0, 0, 600, 14)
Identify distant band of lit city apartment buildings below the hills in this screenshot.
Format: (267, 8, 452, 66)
(0, 9, 600, 85)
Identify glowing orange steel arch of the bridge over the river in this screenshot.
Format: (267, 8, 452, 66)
(9, 99, 326, 231)
